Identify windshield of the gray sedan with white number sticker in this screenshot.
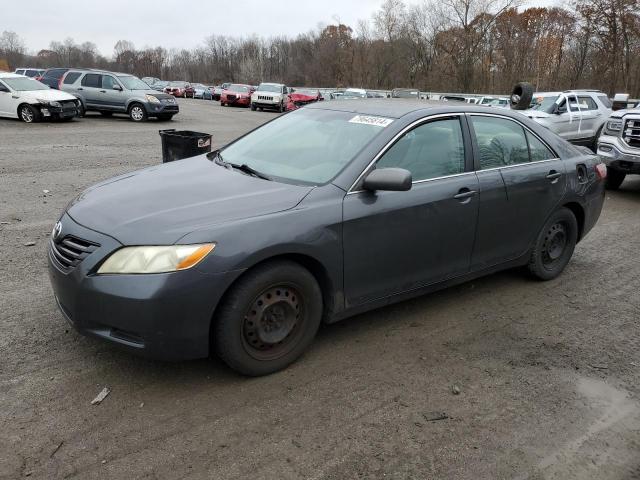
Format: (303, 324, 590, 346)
(221, 109, 390, 185)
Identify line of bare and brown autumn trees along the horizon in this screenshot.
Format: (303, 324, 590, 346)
(0, 0, 640, 97)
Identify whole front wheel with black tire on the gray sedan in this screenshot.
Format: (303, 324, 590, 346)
(211, 261, 322, 376)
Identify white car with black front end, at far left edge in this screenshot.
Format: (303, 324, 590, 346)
(0, 73, 80, 123)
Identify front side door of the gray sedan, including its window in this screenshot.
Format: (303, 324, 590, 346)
(343, 115, 478, 307)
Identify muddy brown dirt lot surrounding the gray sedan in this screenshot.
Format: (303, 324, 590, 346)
(0, 101, 640, 480)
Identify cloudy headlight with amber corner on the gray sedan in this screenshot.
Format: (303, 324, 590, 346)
(98, 243, 216, 275)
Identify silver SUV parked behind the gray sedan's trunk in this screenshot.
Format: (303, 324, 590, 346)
(520, 90, 611, 152)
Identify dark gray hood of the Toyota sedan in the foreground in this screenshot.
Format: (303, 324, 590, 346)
(67, 155, 313, 245)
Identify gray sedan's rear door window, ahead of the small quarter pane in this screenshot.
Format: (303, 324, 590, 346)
(470, 115, 529, 170)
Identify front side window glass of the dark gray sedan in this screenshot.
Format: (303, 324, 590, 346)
(376, 118, 464, 181)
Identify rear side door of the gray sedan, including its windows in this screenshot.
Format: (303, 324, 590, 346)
(469, 114, 567, 269)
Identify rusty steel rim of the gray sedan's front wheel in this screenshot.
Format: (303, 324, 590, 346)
(241, 283, 305, 361)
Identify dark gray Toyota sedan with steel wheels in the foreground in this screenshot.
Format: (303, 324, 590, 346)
(49, 100, 606, 375)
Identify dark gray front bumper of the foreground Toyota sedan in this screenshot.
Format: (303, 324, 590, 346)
(48, 214, 239, 360)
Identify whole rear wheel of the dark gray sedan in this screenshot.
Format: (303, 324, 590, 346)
(528, 207, 578, 280)
